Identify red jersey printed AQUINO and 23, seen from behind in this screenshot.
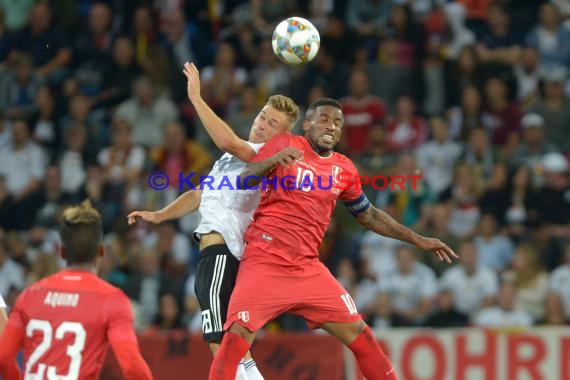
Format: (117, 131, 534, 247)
(0, 269, 152, 380)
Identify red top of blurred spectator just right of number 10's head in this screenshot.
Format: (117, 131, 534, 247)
(340, 95, 386, 154)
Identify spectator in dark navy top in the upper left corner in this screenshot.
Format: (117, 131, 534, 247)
(6, 2, 72, 82)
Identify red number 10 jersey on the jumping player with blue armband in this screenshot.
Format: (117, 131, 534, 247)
(243, 134, 362, 267)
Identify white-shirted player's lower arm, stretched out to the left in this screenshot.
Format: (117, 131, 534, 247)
(127, 190, 202, 224)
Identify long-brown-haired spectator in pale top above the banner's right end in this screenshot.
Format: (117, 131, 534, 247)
(502, 243, 548, 322)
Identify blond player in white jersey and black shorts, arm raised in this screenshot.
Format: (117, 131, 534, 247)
(128, 64, 299, 380)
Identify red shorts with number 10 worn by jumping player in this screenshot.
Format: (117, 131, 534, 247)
(224, 255, 361, 331)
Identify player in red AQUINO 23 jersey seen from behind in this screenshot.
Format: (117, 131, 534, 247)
(0, 201, 152, 380)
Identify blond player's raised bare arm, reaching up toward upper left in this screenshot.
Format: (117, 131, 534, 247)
(183, 62, 255, 162)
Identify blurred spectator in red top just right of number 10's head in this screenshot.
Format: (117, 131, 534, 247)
(340, 69, 386, 155)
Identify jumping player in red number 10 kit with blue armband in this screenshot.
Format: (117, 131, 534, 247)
(209, 99, 457, 380)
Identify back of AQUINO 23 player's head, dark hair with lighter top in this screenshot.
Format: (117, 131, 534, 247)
(59, 200, 103, 265)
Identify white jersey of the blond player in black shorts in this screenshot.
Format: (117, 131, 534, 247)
(194, 142, 263, 260)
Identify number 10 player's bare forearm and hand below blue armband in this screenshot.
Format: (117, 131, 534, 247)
(356, 206, 459, 263)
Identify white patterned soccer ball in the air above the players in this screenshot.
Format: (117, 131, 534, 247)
(271, 17, 321, 65)
